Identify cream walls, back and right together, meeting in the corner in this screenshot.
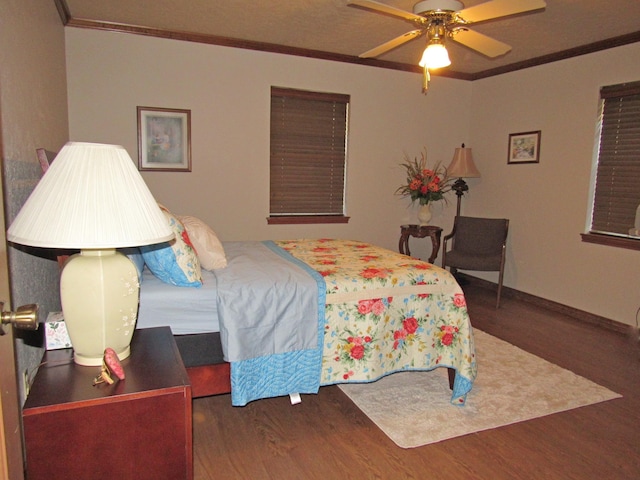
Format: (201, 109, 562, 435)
(66, 28, 640, 324)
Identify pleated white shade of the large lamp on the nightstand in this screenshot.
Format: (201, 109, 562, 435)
(7, 142, 173, 249)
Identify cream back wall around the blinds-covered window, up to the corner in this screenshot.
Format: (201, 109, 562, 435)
(66, 28, 471, 258)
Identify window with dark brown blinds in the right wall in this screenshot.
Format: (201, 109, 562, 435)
(583, 82, 640, 250)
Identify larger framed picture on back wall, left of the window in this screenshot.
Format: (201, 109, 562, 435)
(138, 107, 191, 172)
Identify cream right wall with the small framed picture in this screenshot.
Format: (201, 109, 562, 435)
(464, 43, 640, 325)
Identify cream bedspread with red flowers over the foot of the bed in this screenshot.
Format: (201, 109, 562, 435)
(275, 239, 477, 405)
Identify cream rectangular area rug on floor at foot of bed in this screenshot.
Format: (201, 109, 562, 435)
(339, 330, 621, 448)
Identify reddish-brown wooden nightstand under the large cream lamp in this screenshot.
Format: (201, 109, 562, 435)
(22, 327, 193, 480)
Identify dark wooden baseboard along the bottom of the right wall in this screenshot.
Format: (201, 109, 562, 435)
(464, 273, 635, 334)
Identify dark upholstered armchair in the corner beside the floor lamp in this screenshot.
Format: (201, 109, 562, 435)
(442, 216, 509, 308)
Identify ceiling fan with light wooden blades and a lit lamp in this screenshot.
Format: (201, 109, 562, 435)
(348, 0, 546, 93)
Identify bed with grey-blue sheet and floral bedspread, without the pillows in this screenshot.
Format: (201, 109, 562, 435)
(137, 234, 476, 406)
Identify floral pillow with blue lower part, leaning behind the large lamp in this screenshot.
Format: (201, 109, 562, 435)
(140, 206, 202, 287)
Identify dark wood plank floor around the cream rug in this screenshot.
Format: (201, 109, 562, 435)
(193, 285, 640, 480)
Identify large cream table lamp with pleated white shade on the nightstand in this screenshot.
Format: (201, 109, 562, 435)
(7, 142, 174, 365)
